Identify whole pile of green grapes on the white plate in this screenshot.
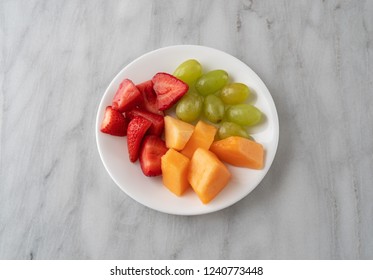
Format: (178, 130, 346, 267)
(173, 59, 262, 139)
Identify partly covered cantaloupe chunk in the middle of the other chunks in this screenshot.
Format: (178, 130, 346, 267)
(181, 121, 217, 158)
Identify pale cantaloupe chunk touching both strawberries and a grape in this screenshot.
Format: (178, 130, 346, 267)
(164, 116, 194, 151)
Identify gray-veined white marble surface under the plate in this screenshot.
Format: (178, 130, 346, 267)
(0, 0, 373, 259)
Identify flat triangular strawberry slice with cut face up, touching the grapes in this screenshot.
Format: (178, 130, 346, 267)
(152, 73, 189, 111)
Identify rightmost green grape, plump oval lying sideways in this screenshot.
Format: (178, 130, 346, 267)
(226, 104, 262, 126)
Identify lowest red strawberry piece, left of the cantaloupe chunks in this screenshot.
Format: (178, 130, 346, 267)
(139, 135, 168, 176)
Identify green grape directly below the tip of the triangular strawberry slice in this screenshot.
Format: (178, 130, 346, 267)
(176, 93, 203, 122)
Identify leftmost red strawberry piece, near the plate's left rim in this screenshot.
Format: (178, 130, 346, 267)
(100, 106, 128, 136)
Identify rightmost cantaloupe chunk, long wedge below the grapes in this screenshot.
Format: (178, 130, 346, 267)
(210, 136, 264, 169)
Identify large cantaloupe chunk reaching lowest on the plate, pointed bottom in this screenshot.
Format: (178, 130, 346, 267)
(188, 148, 231, 204)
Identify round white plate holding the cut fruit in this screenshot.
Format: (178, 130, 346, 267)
(96, 45, 279, 215)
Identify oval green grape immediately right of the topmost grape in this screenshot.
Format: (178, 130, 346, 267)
(195, 70, 229, 96)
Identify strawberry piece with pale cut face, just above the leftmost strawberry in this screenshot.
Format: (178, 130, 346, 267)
(112, 79, 142, 113)
